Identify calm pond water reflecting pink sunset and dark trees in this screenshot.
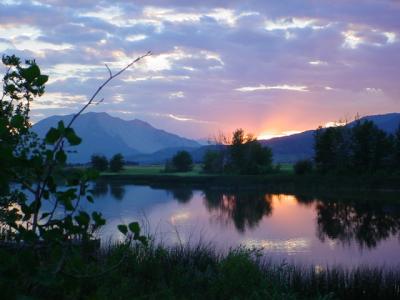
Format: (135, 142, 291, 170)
(85, 182, 400, 267)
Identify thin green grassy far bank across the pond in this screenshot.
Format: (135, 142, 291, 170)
(101, 165, 400, 191)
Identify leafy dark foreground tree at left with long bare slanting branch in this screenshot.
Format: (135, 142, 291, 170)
(0, 55, 150, 298)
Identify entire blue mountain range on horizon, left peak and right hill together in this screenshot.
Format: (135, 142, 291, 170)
(33, 112, 400, 164)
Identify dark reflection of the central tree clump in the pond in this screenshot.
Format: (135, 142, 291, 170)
(203, 190, 272, 233)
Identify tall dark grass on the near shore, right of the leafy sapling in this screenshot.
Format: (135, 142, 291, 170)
(76, 243, 400, 299)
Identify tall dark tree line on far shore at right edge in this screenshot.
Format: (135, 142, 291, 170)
(314, 120, 400, 174)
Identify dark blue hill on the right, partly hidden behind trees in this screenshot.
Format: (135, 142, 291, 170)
(261, 113, 400, 162)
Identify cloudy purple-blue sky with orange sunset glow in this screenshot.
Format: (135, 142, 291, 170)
(0, 0, 400, 138)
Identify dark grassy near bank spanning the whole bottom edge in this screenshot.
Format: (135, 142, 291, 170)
(0, 245, 400, 299)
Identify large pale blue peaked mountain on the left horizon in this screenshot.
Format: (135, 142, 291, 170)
(33, 112, 200, 163)
